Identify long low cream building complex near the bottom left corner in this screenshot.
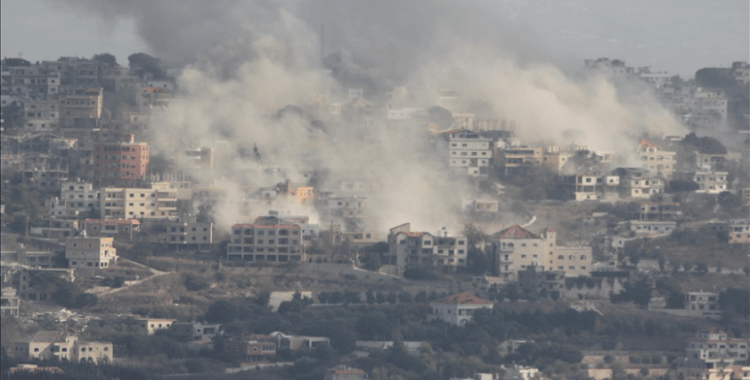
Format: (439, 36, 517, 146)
(13, 331, 113, 364)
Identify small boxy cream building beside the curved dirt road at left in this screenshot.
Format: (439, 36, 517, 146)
(65, 236, 117, 268)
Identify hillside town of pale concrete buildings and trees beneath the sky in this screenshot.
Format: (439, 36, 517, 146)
(0, 35, 750, 380)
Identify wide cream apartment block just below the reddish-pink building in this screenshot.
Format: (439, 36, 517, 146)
(99, 184, 177, 219)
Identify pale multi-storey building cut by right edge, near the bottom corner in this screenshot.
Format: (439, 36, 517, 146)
(685, 327, 750, 363)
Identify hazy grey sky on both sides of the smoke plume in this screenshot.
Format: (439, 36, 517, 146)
(0, 0, 750, 76)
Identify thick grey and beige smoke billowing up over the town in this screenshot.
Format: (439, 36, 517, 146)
(53, 0, 681, 231)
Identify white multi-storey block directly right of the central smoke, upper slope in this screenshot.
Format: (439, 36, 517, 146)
(443, 129, 492, 177)
